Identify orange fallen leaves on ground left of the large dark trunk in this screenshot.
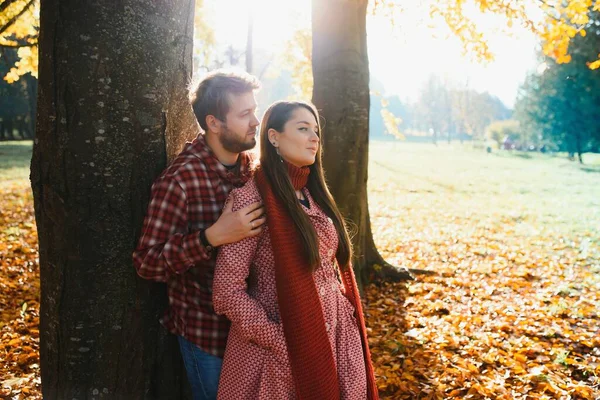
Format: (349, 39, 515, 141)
(0, 181, 41, 399)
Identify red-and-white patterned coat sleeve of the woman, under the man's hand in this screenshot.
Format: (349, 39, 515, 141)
(213, 191, 287, 361)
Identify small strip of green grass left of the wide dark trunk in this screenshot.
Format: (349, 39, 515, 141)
(0, 140, 33, 183)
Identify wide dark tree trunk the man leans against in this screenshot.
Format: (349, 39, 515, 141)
(31, 0, 197, 400)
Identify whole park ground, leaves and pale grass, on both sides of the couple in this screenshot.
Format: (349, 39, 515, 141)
(0, 143, 600, 400)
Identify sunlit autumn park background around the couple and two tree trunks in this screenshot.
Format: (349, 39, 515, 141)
(0, 0, 600, 399)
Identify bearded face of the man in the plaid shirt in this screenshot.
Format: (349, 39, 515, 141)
(219, 92, 259, 153)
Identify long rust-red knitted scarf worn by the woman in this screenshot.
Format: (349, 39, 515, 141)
(255, 163, 378, 400)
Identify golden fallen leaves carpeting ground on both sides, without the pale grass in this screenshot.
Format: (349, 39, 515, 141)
(0, 148, 600, 400)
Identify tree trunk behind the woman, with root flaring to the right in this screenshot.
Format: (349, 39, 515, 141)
(312, 0, 410, 285)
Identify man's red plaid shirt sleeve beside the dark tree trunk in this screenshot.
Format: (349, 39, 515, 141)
(133, 176, 210, 282)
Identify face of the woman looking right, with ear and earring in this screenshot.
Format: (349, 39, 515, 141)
(269, 107, 320, 167)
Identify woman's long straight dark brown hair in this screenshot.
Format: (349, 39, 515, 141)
(260, 101, 352, 271)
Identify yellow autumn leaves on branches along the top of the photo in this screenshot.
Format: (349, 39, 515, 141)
(0, 0, 600, 83)
